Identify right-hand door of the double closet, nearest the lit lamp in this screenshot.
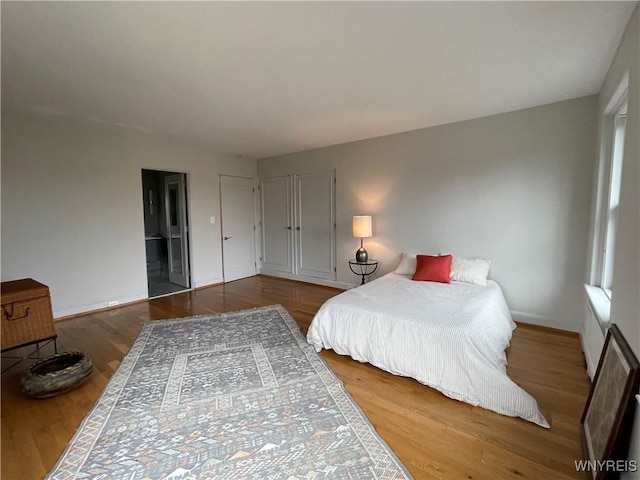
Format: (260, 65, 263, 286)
(295, 172, 336, 280)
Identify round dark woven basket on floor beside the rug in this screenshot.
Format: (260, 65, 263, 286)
(22, 352, 93, 398)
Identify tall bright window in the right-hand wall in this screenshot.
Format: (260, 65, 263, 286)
(591, 90, 627, 302)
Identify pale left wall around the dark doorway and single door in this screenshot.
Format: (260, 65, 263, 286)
(2, 113, 257, 317)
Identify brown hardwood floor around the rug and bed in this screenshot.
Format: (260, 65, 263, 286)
(2, 276, 589, 480)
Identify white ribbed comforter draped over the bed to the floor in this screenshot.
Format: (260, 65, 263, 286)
(307, 273, 549, 428)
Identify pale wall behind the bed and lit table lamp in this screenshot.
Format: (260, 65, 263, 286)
(258, 96, 597, 331)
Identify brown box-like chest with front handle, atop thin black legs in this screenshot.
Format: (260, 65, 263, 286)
(0, 278, 57, 351)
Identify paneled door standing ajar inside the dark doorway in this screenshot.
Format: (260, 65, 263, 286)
(164, 173, 190, 288)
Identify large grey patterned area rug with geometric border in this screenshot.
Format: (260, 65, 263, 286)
(47, 305, 411, 480)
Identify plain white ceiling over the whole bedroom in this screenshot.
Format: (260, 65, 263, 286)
(1, 1, 637, 157)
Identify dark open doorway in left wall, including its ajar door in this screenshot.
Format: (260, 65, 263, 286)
(142, 170, 191, 298)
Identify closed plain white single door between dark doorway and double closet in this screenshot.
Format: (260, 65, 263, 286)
(220, 175, 256, 282)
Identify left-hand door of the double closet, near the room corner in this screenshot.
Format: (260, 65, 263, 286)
(260, 176, 293, 273)
